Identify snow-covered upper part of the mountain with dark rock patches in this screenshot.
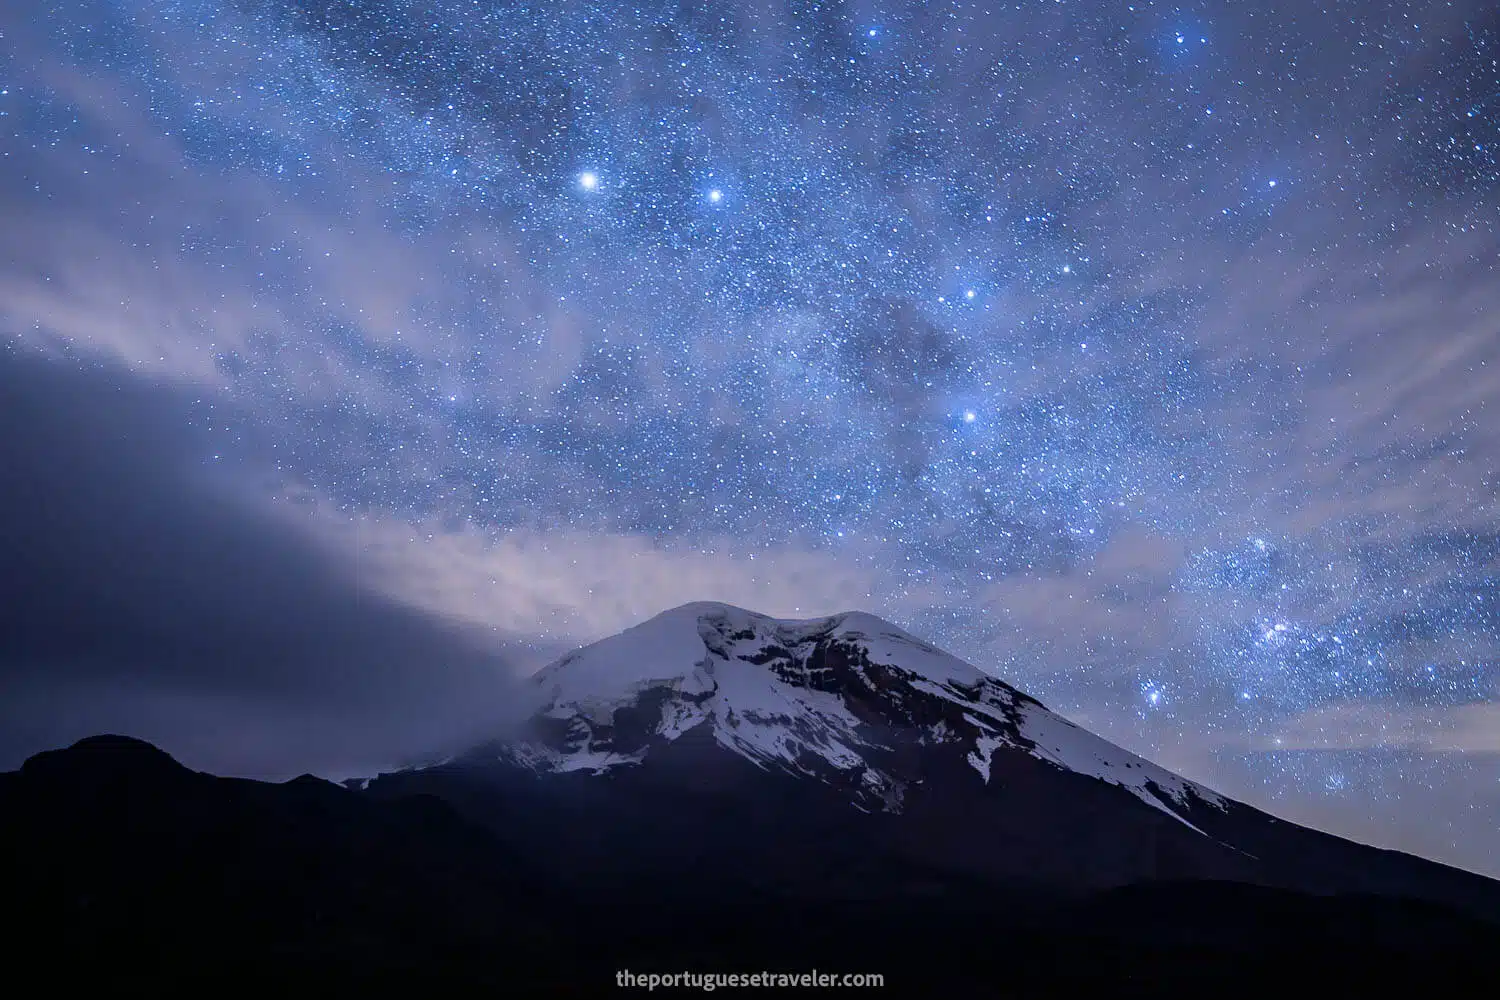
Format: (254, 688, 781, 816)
(506, 603, 1227, 829)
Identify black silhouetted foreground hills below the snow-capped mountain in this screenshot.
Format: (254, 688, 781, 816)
(0, 736, 1500, 997)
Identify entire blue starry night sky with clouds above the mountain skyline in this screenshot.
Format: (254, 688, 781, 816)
(0, 0, 1500, 876)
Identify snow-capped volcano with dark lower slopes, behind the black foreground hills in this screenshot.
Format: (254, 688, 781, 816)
(366, 603, 1500, 915)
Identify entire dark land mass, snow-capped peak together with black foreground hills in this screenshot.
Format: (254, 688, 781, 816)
(11, 603, 1500, 996)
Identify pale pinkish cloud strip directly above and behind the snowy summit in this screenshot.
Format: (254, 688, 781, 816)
(277, 501, 935, 645)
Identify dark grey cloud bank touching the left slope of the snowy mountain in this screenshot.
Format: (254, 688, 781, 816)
(0, 351, 539, 775)
